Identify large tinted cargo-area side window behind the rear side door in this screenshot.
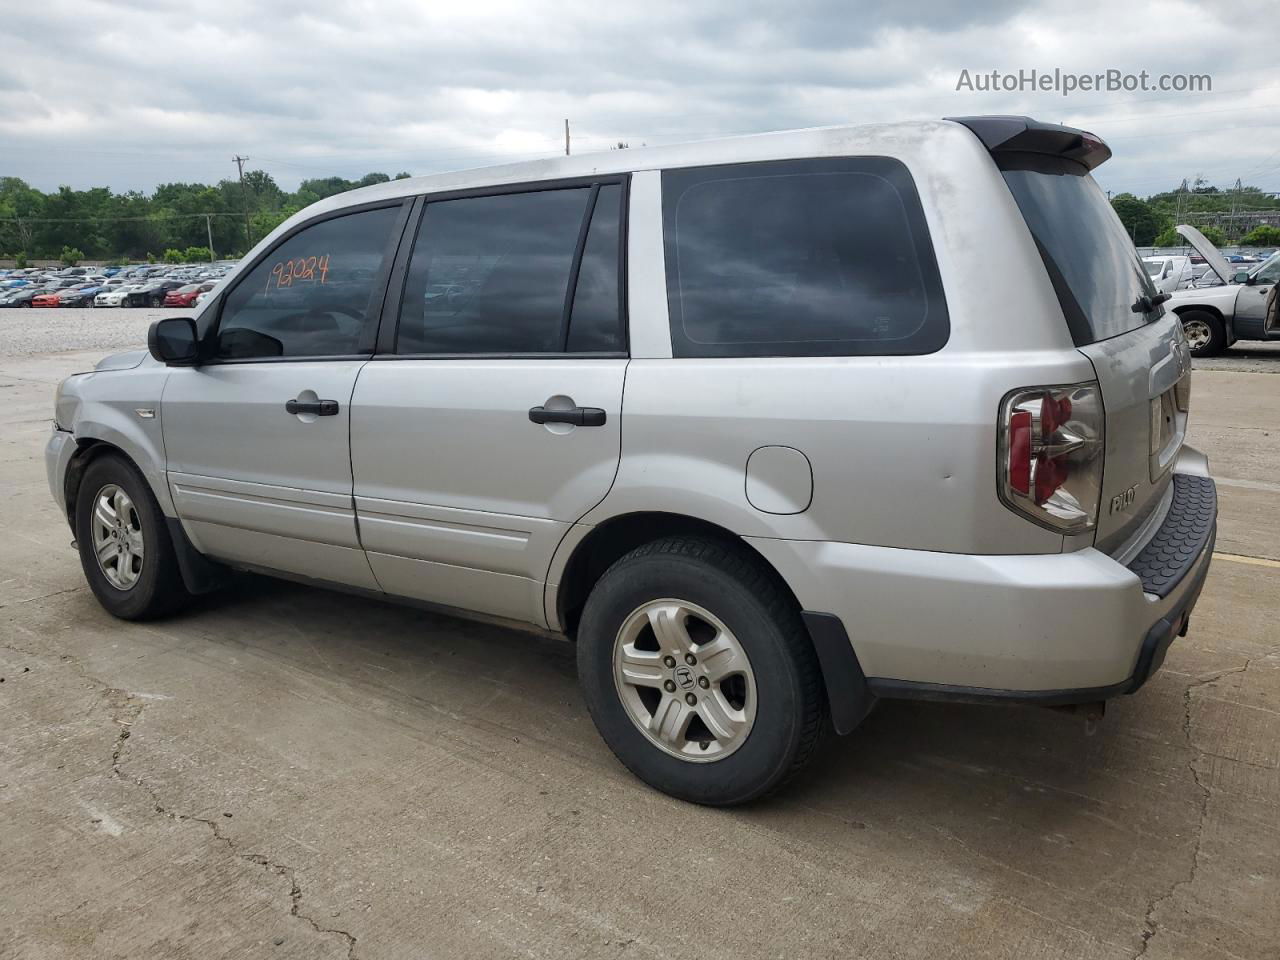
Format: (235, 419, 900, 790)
(663, 157, 948, 357)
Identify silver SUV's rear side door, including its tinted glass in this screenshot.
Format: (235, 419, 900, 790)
(351, 179, 627, 623)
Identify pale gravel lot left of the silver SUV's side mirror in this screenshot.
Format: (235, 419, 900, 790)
(0, 307, 192, 358)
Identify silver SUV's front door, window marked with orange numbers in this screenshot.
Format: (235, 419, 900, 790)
(161, 204, 401, 589)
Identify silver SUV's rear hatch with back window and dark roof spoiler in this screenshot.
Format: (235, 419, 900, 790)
(966, 118, 1190, 553)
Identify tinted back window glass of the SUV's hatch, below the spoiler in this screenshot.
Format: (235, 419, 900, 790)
(1000, 155, 1164, 347)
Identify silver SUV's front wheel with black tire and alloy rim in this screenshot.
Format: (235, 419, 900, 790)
(76, 453, 189, 620)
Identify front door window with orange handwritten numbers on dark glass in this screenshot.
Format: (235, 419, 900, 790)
(215, 206, 399, 360)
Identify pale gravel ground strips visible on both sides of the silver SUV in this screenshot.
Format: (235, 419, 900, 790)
(0, 307, 1280, 374)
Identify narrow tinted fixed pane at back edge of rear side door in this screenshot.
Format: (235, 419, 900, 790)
(567, 184, 625, 353)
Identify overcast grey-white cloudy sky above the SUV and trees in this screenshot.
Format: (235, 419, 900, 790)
(0, 0, 1280, 195)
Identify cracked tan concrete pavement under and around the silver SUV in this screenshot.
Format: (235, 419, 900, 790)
(0, 325, 1280, 960)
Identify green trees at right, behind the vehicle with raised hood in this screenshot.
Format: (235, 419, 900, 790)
(1111, 178, 1280, 247)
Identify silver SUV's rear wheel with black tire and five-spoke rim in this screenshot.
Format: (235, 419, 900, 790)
(577, 536, 827, 806)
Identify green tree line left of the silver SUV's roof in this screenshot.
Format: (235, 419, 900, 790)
(0, 170, 410, 260)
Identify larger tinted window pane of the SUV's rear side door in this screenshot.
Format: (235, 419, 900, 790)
(396, 187, 591, 353)
